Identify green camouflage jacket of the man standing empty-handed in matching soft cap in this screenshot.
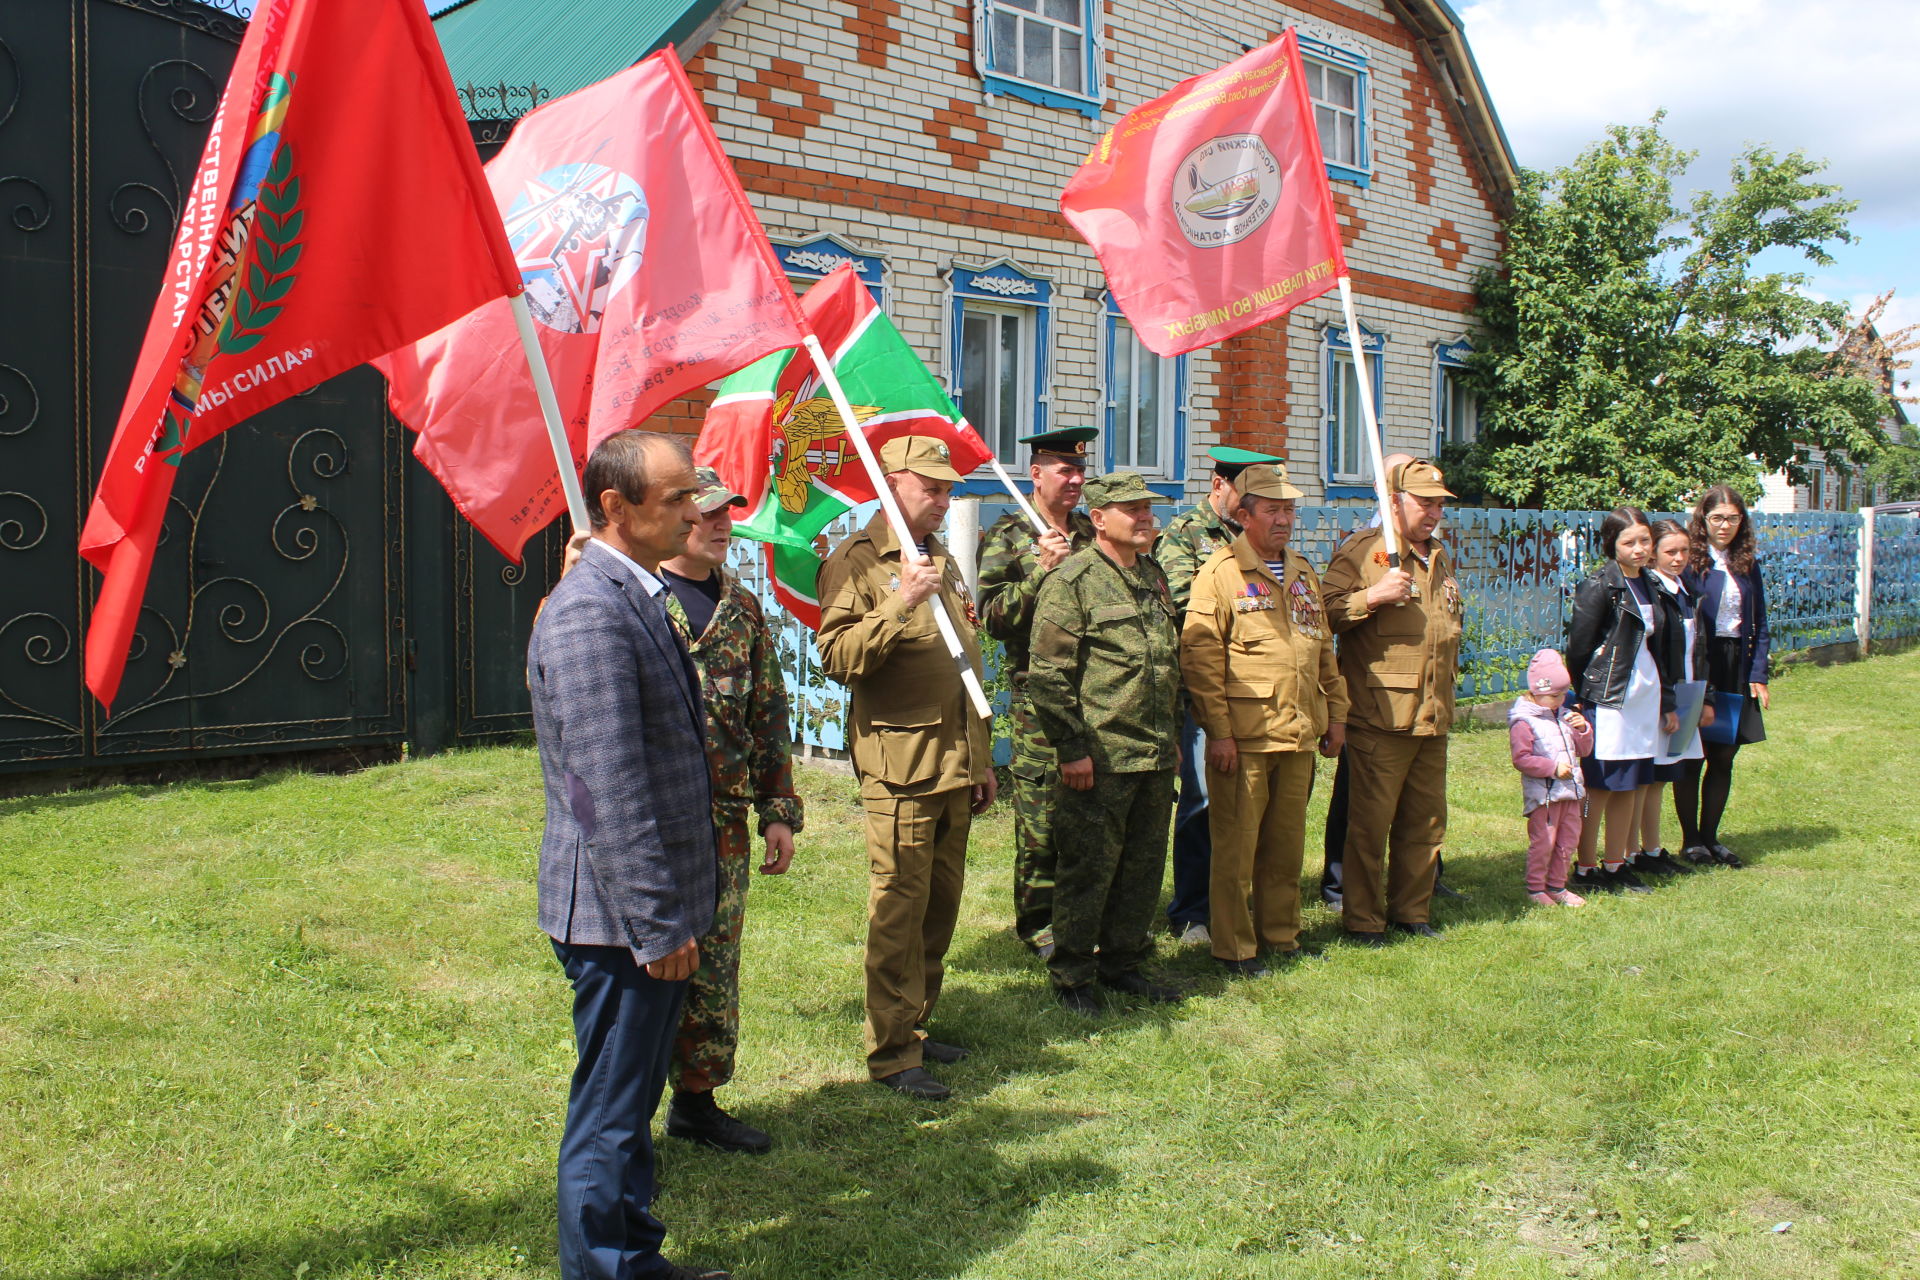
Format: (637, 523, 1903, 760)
(1027, 547, 1181, 773)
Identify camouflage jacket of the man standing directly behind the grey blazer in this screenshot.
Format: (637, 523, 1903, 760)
(660, 570, 804, 835)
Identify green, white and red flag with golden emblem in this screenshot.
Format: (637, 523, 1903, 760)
(693, 267, 993, 629)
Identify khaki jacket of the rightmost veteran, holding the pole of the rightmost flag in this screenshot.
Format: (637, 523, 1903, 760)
(1321, 528, 1461, 737)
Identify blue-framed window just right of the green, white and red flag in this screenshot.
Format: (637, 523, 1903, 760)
(945, 259, 1054, 493)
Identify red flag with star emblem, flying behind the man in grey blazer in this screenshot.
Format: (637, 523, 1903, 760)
(376, 46, 801, 560)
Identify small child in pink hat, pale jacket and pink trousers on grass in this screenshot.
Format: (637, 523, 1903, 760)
(1507, 649, 1594, 906)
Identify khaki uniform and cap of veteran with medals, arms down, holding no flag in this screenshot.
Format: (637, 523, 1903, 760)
(1181, 466, 1348, 961)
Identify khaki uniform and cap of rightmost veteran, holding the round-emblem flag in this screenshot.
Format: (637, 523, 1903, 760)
(1321, 462, 1461, 933)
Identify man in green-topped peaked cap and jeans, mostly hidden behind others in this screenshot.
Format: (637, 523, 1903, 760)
(1154, 445, 1286, 946)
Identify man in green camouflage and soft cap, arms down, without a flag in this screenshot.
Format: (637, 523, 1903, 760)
(1027, 472, 1181, 1013)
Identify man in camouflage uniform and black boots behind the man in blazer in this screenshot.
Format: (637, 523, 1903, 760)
(660, 466, 803, 1151)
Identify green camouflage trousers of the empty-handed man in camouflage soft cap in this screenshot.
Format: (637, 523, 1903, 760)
(1046, 770, 1179, 986)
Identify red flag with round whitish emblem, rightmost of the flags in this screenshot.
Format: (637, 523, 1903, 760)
(1060, 27, 1346, 355)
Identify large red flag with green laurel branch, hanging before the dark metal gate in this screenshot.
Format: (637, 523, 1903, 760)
(81, 0, 520, 704)
